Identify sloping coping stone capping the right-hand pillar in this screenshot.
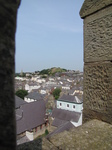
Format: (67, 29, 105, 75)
(80, 0, 112, 18)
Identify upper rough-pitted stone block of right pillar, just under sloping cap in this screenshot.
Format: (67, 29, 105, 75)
(84, 6, 112, 62)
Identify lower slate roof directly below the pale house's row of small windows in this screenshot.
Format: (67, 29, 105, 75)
(51, 108, 81, 122)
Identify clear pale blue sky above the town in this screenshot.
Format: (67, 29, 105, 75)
(15, 0, 84, 72)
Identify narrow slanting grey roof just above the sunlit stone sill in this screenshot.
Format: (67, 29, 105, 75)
(46, 122, 75, 138)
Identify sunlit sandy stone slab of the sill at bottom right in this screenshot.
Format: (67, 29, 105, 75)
(50, 120, 112, 150)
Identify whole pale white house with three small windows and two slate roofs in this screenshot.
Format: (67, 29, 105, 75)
(52, 95, 83, 127)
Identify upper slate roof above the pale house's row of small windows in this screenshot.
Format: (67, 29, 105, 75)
(58, 94, 82, 103)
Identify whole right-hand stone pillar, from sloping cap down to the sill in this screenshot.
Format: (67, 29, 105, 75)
(80, 0, 112, 124)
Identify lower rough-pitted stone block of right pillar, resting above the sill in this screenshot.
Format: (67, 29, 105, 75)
(83, 62, 112, 124)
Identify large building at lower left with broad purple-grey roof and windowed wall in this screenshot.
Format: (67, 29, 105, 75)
(16, 96, 48, 144)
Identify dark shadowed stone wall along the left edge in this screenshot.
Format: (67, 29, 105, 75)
(0, 0, 20, 150)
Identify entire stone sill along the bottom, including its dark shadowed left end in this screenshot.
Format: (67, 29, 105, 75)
(17, 120, 112, 150)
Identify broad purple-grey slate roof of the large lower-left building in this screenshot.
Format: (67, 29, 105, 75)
(16, 100, 46, 134)
